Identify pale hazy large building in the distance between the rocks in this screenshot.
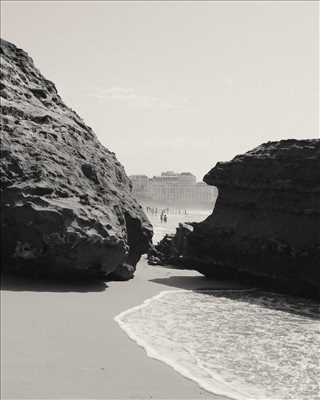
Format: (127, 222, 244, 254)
(130, 171, 217, 208)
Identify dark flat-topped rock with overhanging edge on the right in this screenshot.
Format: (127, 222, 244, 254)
(151, 139, 320, 297)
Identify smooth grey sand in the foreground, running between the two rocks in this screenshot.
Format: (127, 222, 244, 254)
(1, 259, 244, 399)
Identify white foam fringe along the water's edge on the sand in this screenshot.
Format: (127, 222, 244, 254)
(114, 289, 266, 400)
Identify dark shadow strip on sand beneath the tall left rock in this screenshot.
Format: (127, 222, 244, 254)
(0, 274, 108, 293)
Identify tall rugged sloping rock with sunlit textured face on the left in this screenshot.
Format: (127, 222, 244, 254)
(0, 40, 152, 279)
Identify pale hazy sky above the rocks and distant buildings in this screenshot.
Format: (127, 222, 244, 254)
(1, 1, 319, 179)
